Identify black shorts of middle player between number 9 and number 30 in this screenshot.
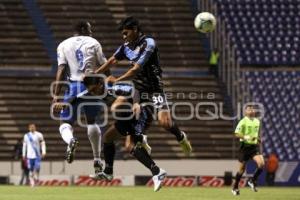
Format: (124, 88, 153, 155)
(115, 106, 153, 136)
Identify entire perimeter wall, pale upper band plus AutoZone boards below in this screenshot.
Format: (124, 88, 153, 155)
(0, 160, 300, 187)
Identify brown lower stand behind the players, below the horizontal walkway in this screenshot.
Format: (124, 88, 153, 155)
(0, 76, 233, 160)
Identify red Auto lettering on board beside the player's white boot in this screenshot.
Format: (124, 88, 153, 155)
(146, 176, 197, 187)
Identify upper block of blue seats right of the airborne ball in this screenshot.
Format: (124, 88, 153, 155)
(216, 0, 300, 65)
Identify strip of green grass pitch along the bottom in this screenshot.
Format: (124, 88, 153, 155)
(0, 186, 300, 200)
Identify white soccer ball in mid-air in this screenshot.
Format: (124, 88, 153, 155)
(194, 12, 217, 33)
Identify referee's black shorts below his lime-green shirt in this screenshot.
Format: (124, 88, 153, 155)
(238, 142, 261, 162)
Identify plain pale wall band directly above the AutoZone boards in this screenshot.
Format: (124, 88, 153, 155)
(0, 160, 237, 176)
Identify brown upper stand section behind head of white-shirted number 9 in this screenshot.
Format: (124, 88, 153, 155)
(37, 0, 121, 59)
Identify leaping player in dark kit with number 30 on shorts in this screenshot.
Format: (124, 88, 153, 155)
(95, 17, 192, 155)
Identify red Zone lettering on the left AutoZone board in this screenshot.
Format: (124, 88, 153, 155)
(74, 176, 122, 187)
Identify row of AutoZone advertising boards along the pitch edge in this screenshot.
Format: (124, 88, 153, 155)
(9, 175, 246, 187)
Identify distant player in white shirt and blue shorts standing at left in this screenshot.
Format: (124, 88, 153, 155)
(22, 124, 46, 187)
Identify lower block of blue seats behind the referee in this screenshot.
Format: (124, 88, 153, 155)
(245, 70, 300, 160)
